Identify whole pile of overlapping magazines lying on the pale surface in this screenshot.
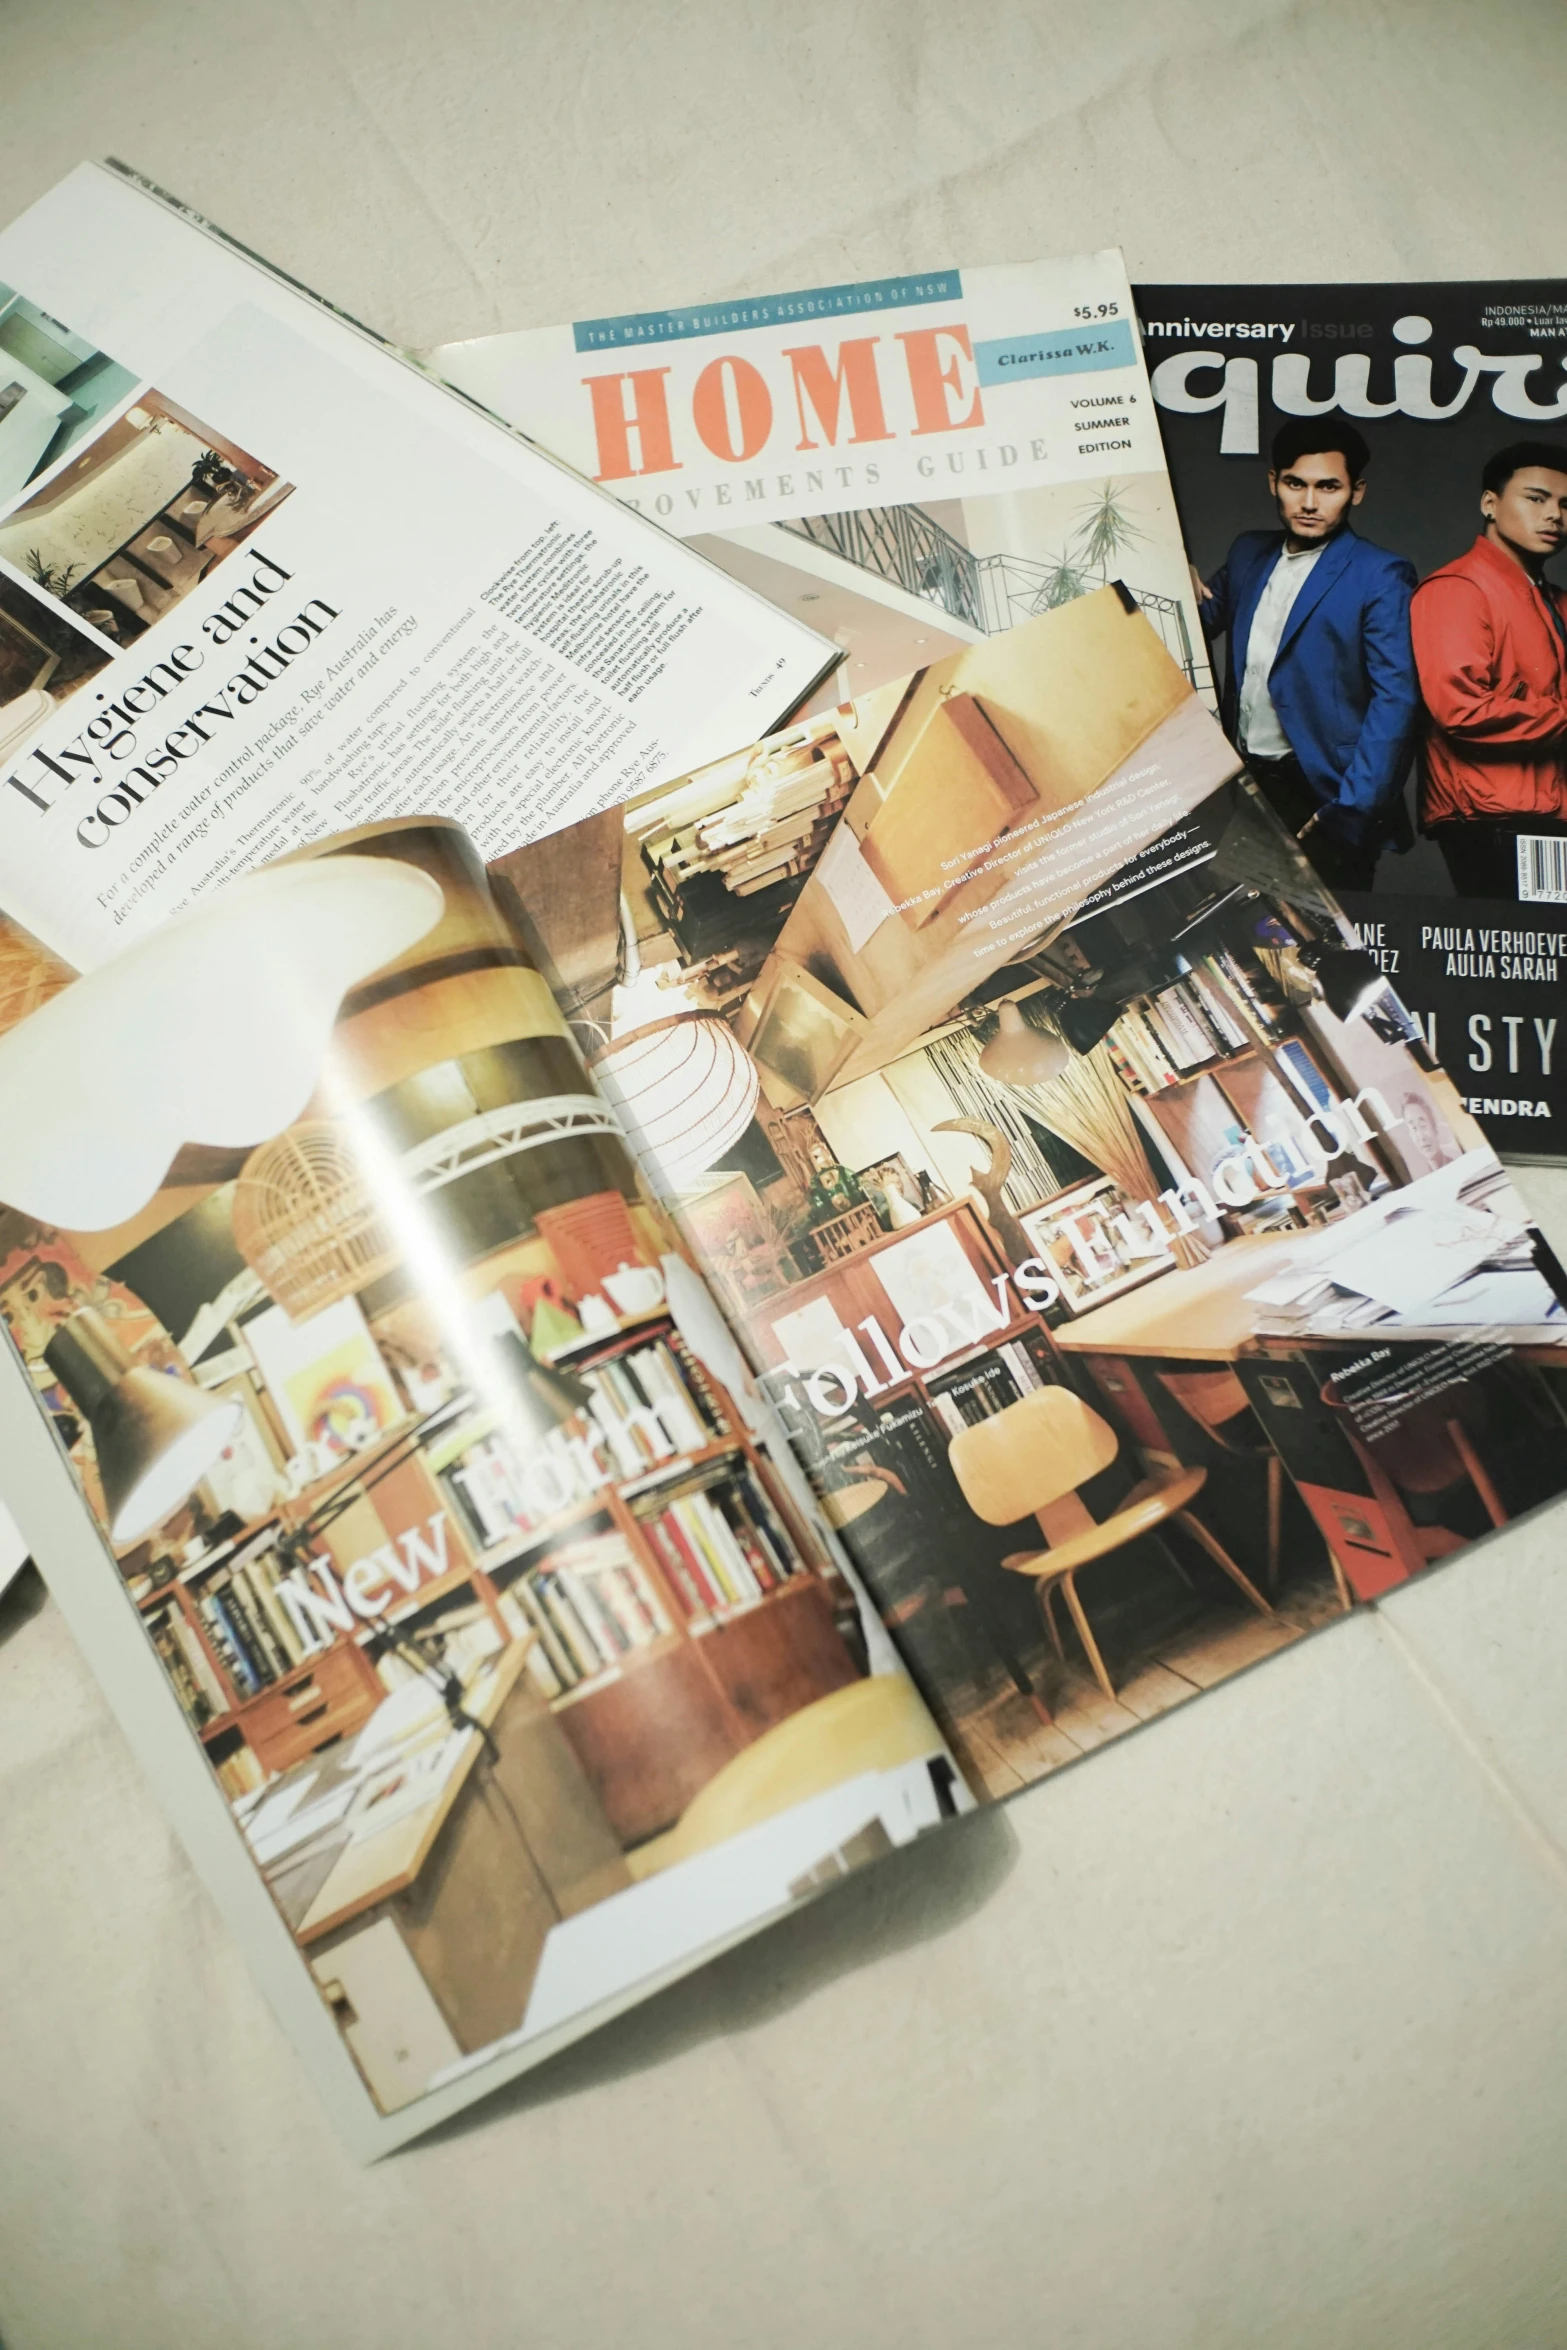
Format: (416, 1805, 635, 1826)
(0, 156, 1567, 2153)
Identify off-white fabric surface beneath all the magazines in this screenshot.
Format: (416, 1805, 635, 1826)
(0, 0, 1567, 2350)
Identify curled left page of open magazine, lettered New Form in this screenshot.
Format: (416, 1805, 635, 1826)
(0, 818, 970, 2150)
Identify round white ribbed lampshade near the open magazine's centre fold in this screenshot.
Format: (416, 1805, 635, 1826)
(592, 1013, 759, 1194)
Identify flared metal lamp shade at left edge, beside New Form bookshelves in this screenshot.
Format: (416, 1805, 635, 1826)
(45, 1307, 244, 1549)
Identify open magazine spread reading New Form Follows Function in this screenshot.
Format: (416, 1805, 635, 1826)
(0, 585, 1567, 2153)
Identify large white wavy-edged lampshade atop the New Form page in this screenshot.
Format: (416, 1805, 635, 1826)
(0, 855, 446, 1231)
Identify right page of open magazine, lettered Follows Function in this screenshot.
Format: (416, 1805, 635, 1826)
(519, 588, 1567, 1795)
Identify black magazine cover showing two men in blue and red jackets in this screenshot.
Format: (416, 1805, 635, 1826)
(1137, 280, 1567, 1161)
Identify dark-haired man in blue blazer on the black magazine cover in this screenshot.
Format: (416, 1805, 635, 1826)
(1193, 416, 1419, 888)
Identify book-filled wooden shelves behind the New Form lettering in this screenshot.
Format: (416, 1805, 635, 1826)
(136, 1314, 859, 1833)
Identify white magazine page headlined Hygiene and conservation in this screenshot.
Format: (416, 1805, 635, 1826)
(0, 167, 832, 968)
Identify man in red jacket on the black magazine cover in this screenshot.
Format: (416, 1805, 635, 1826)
(1410, 442, 1567, 898)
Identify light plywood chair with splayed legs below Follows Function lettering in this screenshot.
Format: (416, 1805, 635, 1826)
(949, 1387, 1273, 1699)
